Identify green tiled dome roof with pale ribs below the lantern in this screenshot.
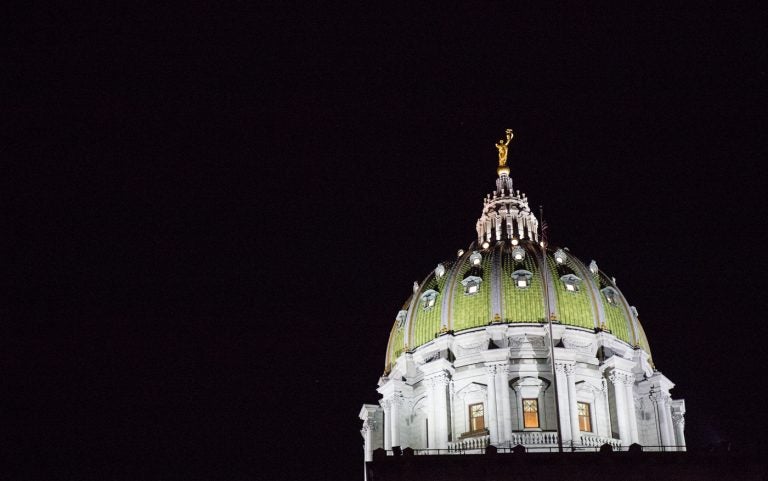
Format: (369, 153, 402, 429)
(386, 244, 650, 371)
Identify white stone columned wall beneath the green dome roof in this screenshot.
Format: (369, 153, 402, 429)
(360, 325, 685, 453)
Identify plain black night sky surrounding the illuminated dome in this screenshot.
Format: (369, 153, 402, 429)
(10, 4, 768, 479)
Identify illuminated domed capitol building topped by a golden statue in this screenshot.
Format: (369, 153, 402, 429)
(359, 130, 685, 461)
